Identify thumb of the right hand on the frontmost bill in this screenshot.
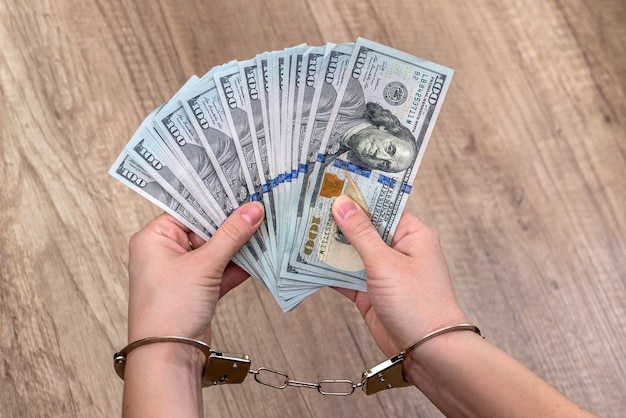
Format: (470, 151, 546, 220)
(333, 196, 387, 266)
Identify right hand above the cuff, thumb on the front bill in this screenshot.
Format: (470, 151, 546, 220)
(333, 196, 467, 356)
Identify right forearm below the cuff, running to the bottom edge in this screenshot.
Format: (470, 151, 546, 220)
(404, 331, 593, 417)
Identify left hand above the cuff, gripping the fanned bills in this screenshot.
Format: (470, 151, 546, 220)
(128, 203, 264, 344)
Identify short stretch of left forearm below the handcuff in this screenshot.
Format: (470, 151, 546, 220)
(122, 343, 204, 418)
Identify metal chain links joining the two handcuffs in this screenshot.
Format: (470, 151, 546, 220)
(248, 367, 363, 396)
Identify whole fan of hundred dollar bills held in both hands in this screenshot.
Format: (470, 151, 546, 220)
(109, 38, 452, 311)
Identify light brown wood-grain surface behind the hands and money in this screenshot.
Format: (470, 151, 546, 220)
(0, 0, 626, 417)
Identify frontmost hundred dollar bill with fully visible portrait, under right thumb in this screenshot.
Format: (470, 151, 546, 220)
(290, 38, 453, 290)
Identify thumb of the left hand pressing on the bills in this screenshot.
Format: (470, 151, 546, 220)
(197, 202, 265, 271)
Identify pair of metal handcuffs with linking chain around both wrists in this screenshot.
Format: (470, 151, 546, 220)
(113, 324, 481, 396)
